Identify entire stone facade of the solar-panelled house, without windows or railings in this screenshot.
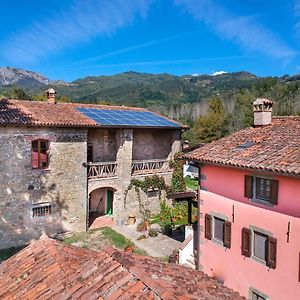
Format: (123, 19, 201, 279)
(0, 127, 180, 248)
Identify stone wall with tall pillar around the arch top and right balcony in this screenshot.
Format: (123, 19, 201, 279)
(88, 129, 180, 220)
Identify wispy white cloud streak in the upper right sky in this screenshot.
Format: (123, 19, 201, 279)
(175, 0, 296, 59)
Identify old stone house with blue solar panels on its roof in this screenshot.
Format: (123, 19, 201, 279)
(0, 89, 183, 248)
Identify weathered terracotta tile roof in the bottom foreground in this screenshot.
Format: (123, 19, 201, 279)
(0, 236, 244, 300)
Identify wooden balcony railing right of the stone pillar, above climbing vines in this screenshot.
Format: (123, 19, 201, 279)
(131, 159, 171, 175)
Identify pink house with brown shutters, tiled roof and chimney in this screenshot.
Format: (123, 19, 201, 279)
(185, 99, 300, 300)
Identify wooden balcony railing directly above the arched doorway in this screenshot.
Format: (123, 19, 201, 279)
(88, 161, 117, 179)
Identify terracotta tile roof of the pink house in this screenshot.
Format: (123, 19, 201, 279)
(184, 116, 300, 176)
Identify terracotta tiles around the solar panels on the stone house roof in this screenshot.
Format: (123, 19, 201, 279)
(0, 99, 186, 128)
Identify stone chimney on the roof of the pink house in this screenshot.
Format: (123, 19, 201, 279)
(253, 98, 274, 127)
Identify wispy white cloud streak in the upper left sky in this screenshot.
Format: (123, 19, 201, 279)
(2, 0, 153, 63)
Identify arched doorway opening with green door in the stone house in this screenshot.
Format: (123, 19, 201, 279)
(88, 187, 115, 227)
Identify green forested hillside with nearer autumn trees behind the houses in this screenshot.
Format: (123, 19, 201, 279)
(0, 68, 300, 143)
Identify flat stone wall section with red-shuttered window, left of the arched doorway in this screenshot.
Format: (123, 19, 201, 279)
(0, 127, 87, 248)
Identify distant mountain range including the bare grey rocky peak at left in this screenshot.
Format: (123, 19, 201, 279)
(0, 67, 300, 118)
